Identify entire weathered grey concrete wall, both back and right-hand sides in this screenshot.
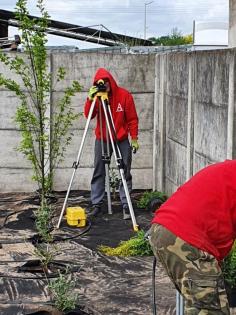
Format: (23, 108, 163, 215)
(0, 49, 236, 194)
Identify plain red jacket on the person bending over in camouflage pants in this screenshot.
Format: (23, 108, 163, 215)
(152, 160, 236, 260)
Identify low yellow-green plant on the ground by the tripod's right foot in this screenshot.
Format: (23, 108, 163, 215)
(99, 230, 153, 257)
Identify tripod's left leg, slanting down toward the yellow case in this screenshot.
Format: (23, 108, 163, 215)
(57, 97, 97, 229)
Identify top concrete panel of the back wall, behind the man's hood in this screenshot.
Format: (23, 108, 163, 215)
(52, 53, 155, 92)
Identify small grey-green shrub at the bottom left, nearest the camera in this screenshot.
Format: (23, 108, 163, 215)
(48, 270, 78, 311)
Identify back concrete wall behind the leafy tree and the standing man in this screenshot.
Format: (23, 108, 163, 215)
(0, 53, 155, 192)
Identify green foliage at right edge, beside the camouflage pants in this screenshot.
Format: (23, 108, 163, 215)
(222, 243, 236, 288)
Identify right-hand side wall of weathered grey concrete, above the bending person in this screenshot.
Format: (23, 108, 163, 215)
(153, 49, 236, 194)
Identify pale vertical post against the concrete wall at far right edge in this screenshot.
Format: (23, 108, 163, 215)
(227, 53, 235, 159)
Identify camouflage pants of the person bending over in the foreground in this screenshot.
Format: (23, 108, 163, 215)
(150, 224, 230, 315)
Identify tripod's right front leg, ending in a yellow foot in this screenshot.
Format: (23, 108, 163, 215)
(101, 98, 138, 231)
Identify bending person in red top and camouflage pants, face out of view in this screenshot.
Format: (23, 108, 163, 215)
(150, 160, 236, 315)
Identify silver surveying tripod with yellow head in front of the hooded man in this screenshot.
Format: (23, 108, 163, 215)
(57, 91, 138, 231)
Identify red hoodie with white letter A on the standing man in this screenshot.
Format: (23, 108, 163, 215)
(84, 68, 138, 140)
